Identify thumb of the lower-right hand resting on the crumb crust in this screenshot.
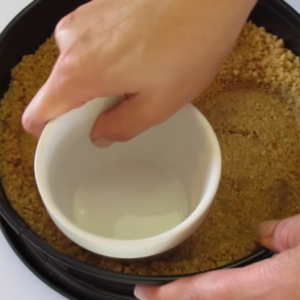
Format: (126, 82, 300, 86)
(258, 215, 300, 253)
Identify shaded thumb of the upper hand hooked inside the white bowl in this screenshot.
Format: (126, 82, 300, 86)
(91, 93, 186, 147)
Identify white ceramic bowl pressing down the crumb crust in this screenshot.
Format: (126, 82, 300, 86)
(35, 97, 221, 259)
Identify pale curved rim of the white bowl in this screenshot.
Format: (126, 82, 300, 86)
(34, 101, 222, 259)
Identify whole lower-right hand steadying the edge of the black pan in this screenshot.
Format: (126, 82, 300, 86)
(135, 215, 300, 300)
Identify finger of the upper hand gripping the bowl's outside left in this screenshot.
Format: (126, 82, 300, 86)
(22, 58, 92, 137)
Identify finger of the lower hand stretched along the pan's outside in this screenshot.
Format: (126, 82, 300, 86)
(134, 247, 300, 300)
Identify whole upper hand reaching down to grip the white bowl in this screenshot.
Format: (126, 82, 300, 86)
(22, 0, 257, 147)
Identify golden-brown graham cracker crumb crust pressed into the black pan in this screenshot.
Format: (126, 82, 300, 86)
(0, 23, 300, 275)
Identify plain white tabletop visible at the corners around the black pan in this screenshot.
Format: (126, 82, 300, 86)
(0, 0, 300, 300)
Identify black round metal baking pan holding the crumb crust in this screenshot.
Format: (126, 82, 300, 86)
(0, 0, 300, 300)
